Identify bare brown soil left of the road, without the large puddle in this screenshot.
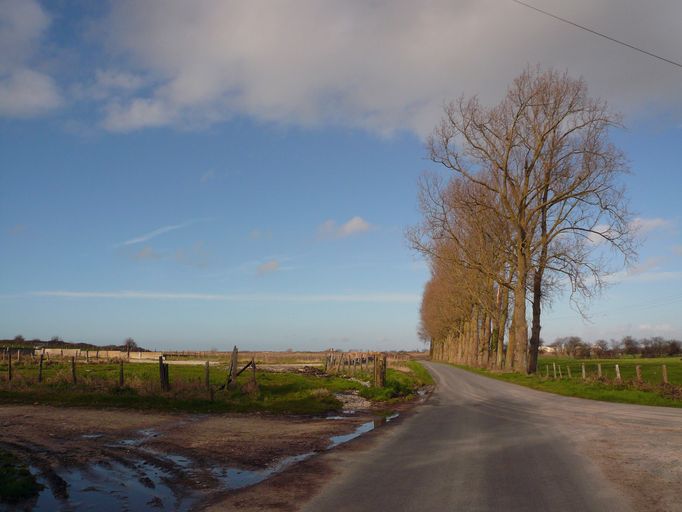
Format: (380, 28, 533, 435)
(0, 405, 371, 504)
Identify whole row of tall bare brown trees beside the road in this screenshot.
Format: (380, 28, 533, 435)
(407, 67, 635, 373)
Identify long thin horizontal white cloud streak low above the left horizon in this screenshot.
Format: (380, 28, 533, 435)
(29, 290, 421, 304)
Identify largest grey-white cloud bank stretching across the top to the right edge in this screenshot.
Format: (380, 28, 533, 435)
(94, 0, 682, 134)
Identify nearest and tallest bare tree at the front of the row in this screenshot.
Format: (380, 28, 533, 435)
(427, 67, 634, 372)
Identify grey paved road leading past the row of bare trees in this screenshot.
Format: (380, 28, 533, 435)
(304, 363, 682, 512)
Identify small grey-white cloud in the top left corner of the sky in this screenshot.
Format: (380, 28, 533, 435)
(0, 0, 62, 117)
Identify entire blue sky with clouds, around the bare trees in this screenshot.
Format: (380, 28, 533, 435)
(0, 0, 682, 350)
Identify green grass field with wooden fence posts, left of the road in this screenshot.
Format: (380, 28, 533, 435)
(0, 361, 430, 414)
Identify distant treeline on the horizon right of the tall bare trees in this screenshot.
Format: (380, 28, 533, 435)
(548, 336, 682, 358)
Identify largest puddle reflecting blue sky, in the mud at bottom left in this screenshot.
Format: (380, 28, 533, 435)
(33, 462, 196, 512)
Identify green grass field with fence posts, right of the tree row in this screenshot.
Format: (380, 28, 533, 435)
(452, 357, 682, 407)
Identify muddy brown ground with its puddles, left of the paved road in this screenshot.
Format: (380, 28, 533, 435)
(0, 405, 388, 512)
